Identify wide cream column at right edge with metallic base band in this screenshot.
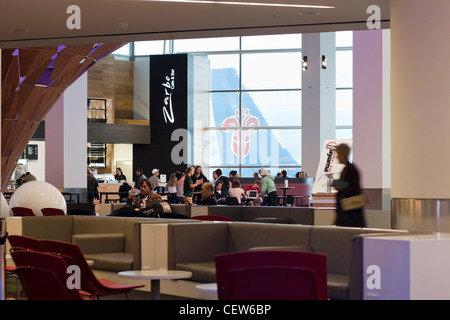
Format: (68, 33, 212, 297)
(390, 0, 450, 232)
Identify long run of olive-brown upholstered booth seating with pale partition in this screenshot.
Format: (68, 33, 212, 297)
(2, 212, 412, 300)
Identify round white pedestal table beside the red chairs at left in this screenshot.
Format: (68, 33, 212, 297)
(119, 269, 192, 300)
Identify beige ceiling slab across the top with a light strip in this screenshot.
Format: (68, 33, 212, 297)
(0, 0, 389, 48)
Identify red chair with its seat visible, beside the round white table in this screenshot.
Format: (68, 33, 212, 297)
(40, 240, 144, 299)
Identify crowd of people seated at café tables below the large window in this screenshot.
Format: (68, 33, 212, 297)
(111, 165, 300, 217)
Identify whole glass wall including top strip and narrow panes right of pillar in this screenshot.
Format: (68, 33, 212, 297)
(111, 32, 353, 178)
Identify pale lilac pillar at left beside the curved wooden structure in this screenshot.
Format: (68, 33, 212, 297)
(45, 74, 87, 202)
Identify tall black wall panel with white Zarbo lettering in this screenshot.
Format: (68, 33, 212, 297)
(133, 54, 189, 177)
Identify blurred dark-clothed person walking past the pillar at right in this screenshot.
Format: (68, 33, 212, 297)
(333, 143, 366, 228)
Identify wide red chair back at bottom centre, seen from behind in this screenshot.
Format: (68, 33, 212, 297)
(215, 251, 328, 300)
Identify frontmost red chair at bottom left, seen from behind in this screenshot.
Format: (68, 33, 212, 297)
(11, 251, 91, 300)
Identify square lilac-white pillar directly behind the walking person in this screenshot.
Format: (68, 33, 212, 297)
(353, 30, 391, 210)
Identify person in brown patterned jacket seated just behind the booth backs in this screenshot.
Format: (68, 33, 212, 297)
(110, 179, 164, 217)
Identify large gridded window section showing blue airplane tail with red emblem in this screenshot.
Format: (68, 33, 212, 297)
(207, 34, 302, 177)
